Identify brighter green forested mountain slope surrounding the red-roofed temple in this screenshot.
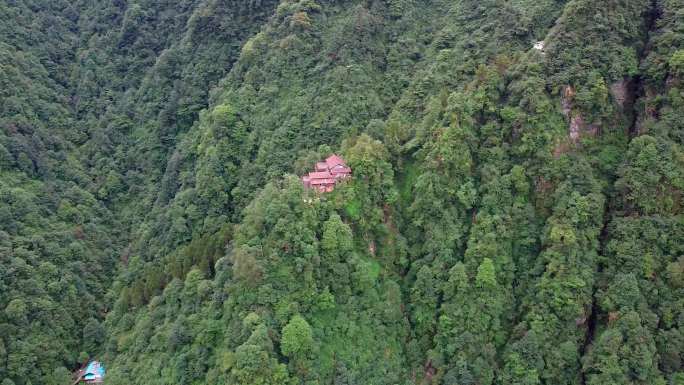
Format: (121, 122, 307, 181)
(101, 1, 681, 384)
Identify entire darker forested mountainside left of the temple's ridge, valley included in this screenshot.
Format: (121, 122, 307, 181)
(0, 1, 275, 385)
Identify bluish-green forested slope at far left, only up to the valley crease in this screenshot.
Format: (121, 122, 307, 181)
(0, 1, 120, 384)
